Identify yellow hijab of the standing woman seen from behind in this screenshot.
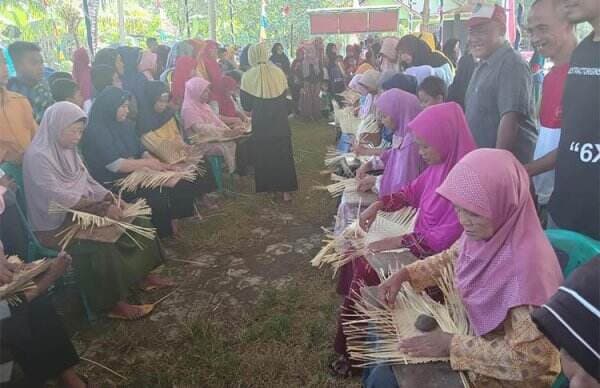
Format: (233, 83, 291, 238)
(241, 43, 288, 98)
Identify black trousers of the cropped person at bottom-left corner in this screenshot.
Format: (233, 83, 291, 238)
(0, 296, 79, 387)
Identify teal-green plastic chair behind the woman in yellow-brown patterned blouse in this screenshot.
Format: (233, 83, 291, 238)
(546, 229, 600, 388)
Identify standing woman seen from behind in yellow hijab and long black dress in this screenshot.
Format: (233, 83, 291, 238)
(241, 44, 298, 201)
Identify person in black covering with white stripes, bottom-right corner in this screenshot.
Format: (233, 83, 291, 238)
(532, 256, 600, 388)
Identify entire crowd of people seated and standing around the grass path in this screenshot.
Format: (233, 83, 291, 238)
(0, 0, 600, 387)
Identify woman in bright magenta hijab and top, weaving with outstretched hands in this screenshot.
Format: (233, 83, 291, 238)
(360, 102, 475, 257)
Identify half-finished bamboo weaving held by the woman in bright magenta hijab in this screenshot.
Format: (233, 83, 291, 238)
(311, 206, 417, 276)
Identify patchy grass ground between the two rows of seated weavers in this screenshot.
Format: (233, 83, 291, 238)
(62, 121, 360, 387)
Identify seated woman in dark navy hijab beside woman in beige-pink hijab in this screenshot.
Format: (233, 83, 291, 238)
(81, 86, 195, 237)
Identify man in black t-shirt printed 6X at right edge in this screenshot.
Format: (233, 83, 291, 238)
(549, 0, 600, 240)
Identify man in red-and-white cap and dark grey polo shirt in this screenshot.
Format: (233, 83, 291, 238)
(465, 4, 537, 163)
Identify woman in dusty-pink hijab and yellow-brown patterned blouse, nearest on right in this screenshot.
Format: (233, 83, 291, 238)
(366, 148, 562, 387)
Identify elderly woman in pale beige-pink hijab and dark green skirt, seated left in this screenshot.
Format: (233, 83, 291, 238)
(23, 102, 169, 319)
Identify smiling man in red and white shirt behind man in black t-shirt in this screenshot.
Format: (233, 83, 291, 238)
(525, 0, 577, 209)
